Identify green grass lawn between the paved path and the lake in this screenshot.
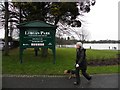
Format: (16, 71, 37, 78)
(2, 48, 118, 75)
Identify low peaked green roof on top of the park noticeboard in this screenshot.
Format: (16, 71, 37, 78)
(18, 21, 57, 28)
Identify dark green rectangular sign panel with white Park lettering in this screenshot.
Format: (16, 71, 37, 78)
(21, 30, 53, 48)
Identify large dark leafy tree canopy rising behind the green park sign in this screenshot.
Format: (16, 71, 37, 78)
(0, 0, 95, 56)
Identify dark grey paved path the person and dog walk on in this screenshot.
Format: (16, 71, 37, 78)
(2, 74, 120, 88)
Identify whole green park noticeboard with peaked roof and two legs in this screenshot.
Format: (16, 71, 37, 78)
(18, 21, 57, 63)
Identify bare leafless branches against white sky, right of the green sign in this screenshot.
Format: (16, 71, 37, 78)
(57, 25, 90, 43)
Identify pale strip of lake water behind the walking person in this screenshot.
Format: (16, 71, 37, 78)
(57, 43, 120, 50)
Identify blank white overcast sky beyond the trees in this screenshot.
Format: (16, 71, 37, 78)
(0, 0, 120, 40)
